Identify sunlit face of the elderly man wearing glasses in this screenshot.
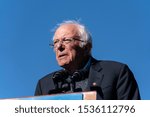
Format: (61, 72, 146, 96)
(54, 24, 83, 67)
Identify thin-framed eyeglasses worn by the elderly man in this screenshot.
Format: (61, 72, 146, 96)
(49, 38, 85, 48)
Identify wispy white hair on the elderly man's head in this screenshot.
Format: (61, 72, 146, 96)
(53, 20, 92, 48)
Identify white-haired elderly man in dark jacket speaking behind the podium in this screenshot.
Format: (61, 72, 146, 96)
(35, 21, 140, 100)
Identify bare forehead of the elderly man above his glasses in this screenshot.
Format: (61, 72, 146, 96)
(54, 24, 80, 39)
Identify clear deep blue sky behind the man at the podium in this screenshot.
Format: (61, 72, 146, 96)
(0, 0, 150, 99)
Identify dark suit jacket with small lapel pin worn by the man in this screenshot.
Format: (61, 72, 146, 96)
(35, 58, 140, 100)
